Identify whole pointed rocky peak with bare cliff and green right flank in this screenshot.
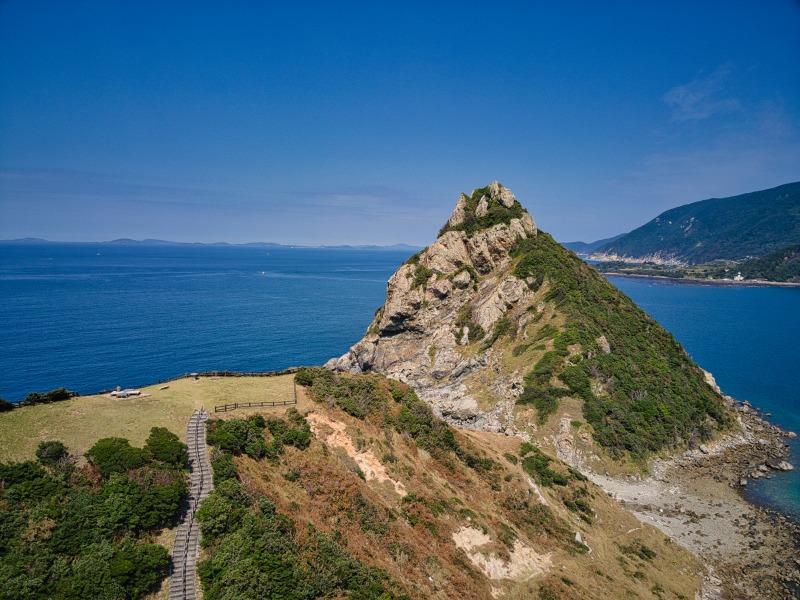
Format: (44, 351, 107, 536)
(326, 182, 727, 462)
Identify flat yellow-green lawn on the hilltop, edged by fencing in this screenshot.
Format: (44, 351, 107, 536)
(0, 375, 293, 462)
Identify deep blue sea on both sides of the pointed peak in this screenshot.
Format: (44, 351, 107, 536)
(0, 244, 800, 518)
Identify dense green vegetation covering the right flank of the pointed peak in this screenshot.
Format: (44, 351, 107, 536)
(512, 233, 728, 457)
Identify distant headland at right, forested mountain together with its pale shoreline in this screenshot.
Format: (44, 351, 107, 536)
(564, 182, 800, 284)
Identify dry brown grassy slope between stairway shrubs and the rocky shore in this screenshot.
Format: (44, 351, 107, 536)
(200, 375, 698, 599)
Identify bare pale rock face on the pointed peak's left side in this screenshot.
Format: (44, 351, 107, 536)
(327, 182, 537, 431)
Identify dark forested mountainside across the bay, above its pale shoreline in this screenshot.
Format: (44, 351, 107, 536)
(597, 182, 800, 263)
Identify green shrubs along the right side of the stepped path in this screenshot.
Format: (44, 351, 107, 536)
(197, 406, 404, 600)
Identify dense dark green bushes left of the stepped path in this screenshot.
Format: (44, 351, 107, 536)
(0, 428, 187, 600)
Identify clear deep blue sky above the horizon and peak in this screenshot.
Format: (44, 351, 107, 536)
(0, 0, 800, 244)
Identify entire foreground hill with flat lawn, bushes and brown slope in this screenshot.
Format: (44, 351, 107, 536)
(0, 368, 704, 600)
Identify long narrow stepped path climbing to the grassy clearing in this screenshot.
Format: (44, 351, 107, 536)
(169, 410, 214, 600)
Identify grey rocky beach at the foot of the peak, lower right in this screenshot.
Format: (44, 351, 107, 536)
(590, 398, 800, 600)
